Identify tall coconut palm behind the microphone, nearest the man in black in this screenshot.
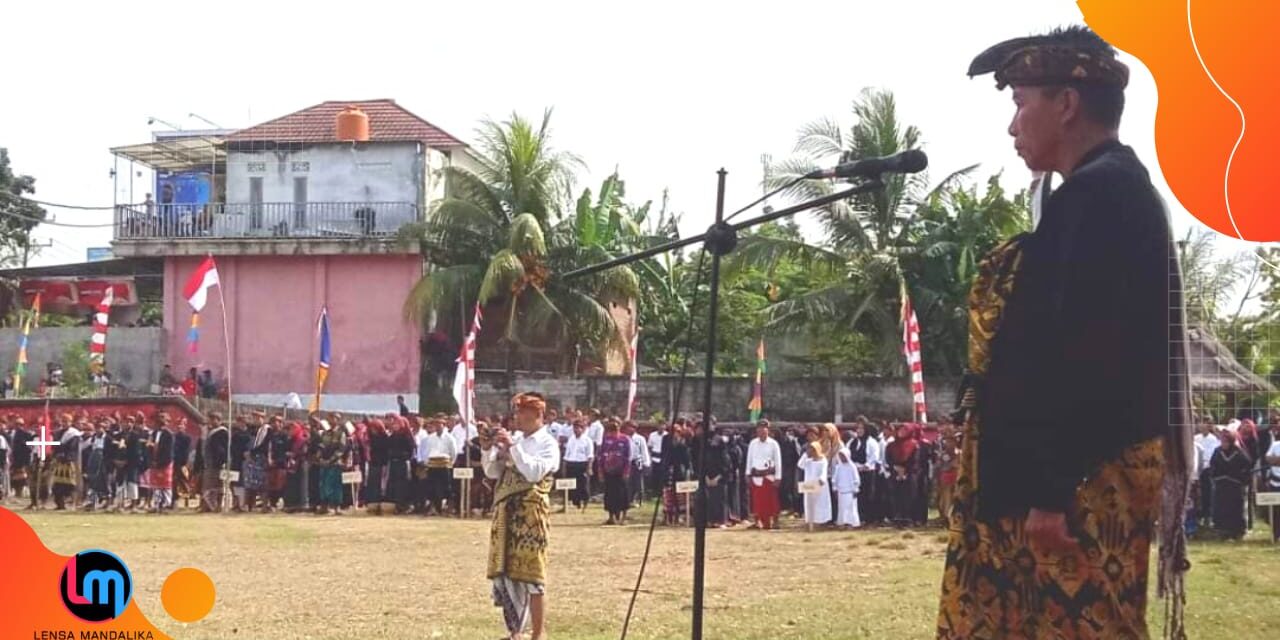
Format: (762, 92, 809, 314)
(732, 90, 975, 372)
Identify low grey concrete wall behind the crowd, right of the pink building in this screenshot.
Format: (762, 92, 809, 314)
(476, 371, 960, 421)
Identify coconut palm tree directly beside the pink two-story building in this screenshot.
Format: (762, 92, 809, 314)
(402, 110, 648, 371)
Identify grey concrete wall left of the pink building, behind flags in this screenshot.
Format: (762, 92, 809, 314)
(0, 326, 166, 390)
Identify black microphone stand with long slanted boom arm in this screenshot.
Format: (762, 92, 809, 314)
(564, 169, 884, 640)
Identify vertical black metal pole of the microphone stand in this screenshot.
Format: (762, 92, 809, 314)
(691, 169, 726, 640)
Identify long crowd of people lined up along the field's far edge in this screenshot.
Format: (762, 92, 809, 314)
(0, 407, 1280, 538)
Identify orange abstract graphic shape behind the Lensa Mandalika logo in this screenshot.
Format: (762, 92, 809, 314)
(0, 508, 169, 640)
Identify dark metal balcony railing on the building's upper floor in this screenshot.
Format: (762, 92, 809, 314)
(115, 202, 419, 241)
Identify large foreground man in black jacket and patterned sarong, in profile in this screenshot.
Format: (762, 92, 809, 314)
(937, 27, 1192, 639)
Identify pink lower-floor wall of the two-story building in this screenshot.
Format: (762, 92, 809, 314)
(164, 255, 422, 398)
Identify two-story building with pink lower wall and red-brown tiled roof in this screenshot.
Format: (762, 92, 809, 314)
(113, 100, 466, 411)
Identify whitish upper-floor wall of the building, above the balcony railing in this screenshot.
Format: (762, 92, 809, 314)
(227, 142, 425, 205)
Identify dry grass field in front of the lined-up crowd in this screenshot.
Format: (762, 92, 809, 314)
(10, 504, 1280, 640)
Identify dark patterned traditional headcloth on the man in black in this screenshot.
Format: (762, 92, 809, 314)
(969, 27, 1129, 88)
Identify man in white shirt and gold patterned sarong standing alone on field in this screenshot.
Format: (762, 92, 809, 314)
(480, 393, 561, 640)
